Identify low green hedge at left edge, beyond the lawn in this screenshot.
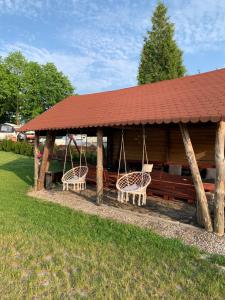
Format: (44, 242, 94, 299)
(0, 140, 34, 156)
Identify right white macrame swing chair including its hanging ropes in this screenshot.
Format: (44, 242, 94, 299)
(116, 127, 153, 206)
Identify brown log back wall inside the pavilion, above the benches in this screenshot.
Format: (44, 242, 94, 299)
(112, 123, 216, 167)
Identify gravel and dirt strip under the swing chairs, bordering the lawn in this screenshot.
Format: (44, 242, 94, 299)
(29, 187, 225, 255)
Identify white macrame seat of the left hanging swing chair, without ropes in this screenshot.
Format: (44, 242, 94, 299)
(62, 166, 88, 191)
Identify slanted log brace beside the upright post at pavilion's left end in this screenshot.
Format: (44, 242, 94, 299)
(37, 131, 55, 191)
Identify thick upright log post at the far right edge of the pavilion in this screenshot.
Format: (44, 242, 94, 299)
(214, 121, 225, 236)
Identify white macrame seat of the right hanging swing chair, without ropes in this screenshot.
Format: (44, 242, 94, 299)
(116, 172, 151, 206)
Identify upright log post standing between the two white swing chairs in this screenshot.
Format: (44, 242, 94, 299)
(96, 128, 103, 205)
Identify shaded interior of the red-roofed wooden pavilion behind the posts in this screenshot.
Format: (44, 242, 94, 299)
(35, 122, 220, 229)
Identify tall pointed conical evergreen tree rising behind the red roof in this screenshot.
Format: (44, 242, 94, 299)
(137, 1, 186, 84)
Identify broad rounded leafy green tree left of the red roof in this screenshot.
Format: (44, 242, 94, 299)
(0, 52, 74, 123)
